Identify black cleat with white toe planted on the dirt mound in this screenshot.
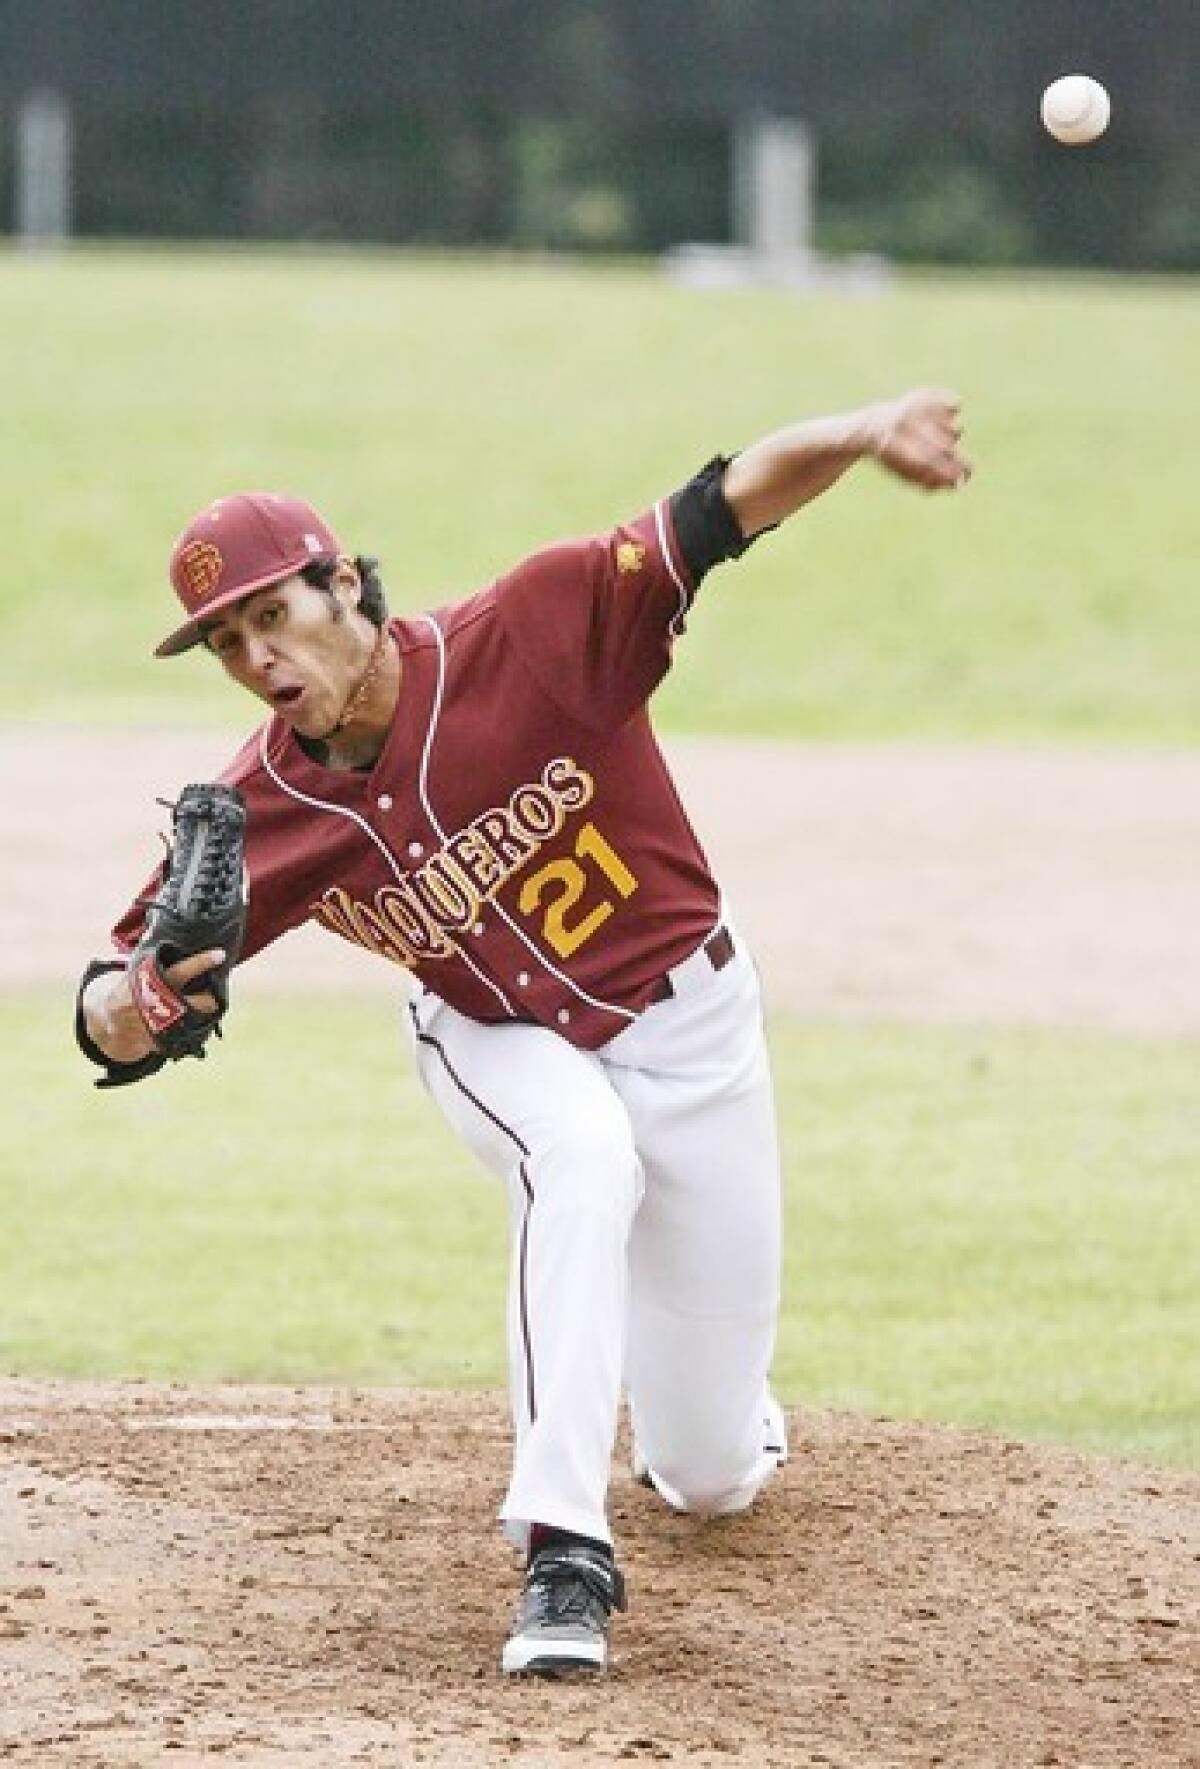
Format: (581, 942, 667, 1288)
(501, 1543, 625, 1677)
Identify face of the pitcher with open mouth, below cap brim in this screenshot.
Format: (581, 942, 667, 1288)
(205, 577, 363, 738)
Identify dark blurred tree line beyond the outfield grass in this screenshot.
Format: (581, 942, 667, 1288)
(0, 0, 1200, 269)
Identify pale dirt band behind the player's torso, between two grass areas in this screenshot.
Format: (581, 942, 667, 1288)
(0, 727, 1200, 1037)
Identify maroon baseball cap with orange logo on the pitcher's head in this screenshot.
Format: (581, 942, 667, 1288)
(154, 492, 342, 658)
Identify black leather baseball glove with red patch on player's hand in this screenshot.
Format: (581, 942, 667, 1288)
(129, 785, 246, 1061)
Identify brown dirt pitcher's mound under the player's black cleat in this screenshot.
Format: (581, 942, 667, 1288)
(0, 1383, 1200, 1769)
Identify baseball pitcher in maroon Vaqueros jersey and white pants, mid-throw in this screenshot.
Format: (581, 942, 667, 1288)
(76, 389, 970, 1673)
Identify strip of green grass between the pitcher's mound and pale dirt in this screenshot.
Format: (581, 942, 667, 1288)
(0, 998, 1200, 1463)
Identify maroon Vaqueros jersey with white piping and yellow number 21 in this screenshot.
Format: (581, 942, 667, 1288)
(113, 501, 719, 1049)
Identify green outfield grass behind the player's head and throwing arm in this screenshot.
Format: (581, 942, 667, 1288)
(0, 251, 1200, 743)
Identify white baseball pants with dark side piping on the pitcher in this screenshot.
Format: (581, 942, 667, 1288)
(409, 934, 782, 1546)
